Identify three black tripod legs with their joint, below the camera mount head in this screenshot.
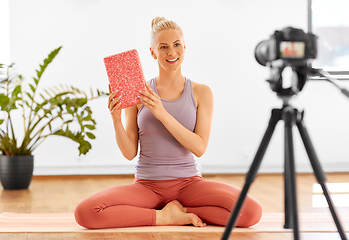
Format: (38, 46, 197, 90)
(222, 99, 347, 240)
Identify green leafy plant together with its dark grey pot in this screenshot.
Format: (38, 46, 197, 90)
(0, 47, 107, 189)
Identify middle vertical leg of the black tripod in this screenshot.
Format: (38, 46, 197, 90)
(283, 108, 299, 240)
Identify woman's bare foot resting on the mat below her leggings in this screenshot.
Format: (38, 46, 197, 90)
(155, 200, 206, 227)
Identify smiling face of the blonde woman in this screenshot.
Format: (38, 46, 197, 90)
(150, 29, 185, 71)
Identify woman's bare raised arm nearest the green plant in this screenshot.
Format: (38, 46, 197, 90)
(108, 87, 138, 161)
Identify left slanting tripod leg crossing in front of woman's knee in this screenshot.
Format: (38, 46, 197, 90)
(222, 109, 281, 240)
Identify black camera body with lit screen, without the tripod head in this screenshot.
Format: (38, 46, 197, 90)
(255, 27, 317, 66)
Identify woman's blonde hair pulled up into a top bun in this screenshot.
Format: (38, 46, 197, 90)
(150, 17, 183, 47)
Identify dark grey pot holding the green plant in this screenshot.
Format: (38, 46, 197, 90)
(0, 155, 34, 189)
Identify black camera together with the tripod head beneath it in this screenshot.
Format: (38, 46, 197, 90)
(255, 27, 317, 96)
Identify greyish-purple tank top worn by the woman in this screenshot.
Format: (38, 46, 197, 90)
(135, 78, 200, 180)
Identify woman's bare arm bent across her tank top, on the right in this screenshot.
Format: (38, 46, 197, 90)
(141, 83, 213, 157)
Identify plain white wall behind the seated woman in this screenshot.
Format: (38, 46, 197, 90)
(6, 0, 349, 175)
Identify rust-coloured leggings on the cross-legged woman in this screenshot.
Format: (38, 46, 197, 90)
(74, 176, 262, 229)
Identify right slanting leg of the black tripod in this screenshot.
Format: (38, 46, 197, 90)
(297, 113, 347, 240)
